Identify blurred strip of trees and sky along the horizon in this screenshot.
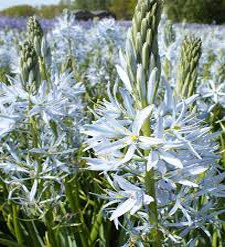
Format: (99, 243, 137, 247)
(0, 0, 225, 24)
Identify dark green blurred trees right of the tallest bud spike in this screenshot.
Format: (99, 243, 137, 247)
(165, 0, 225, 24)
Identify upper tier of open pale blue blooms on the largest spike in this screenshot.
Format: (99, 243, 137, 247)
(84, 80, 216, 173)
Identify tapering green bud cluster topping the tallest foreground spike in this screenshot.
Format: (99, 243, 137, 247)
(125, 0, 162, 106)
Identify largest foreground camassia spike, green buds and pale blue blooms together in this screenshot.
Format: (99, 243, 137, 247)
(83, 0, 225, 246)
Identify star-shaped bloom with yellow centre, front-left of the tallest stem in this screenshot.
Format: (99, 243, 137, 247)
(84, 105, 162, 170)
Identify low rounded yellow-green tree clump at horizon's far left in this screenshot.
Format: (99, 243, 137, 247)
(1, 5, 37, 17)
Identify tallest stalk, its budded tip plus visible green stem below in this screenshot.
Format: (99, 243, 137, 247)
(122, 0, 162, 244)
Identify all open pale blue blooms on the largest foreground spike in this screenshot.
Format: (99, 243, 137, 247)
(84, 65, 225, 242)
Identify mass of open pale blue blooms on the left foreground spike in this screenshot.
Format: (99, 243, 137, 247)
(0, 65, 85, 216)
